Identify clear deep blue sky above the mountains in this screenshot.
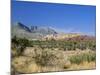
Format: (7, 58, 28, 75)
(11, 1, 96, 35)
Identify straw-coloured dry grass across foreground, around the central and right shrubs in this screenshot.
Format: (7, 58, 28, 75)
(12, 50, 96, 73)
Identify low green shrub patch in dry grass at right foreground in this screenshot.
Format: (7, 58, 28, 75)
(69, 52, 96, 64)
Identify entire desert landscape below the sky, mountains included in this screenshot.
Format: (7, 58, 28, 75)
(11, 22, 96, 75)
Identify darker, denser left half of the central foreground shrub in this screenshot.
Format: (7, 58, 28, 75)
(35, 49, 56, 66)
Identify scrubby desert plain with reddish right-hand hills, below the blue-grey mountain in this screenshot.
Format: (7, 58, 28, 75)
(11, 34, 96, 75)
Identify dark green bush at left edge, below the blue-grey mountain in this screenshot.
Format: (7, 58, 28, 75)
(11, 36, 32, 56)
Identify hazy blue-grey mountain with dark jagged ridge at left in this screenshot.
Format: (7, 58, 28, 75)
(11, 22, 57, 39)
